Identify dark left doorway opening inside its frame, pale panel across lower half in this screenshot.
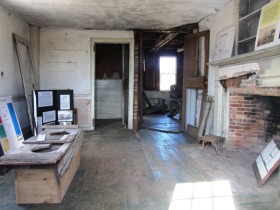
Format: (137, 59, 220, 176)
(95, 43, 129, 130)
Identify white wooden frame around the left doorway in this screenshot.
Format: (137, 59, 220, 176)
(90, 38, 134, 130)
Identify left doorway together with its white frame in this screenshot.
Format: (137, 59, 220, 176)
(92, 40, 133, 129)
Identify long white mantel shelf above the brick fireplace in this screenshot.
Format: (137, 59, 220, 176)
(208, 45, 280, 67)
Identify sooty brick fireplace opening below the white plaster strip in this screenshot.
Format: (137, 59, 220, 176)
(228, 93, 280, 148)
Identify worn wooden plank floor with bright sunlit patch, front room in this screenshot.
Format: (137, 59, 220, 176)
(0, 119, 280, 210)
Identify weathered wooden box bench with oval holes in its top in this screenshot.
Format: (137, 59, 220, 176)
(0, 126, 83, 204)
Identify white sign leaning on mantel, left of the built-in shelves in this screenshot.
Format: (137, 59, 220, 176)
(213, 26, 235, 61)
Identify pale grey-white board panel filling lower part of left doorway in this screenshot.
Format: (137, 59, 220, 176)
(95, 79, 123, 119)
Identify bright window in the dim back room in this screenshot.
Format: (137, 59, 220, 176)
(159, 56, 177, 90)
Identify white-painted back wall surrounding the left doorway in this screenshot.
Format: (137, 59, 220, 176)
(40, 28, 134, 129)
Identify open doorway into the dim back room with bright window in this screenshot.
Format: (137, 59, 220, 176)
(143, 52, 182, 133)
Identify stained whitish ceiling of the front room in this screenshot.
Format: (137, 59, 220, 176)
(0, 0, 230, 30)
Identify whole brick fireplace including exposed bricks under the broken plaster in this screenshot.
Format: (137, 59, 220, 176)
(224, 74, 280, 149)
